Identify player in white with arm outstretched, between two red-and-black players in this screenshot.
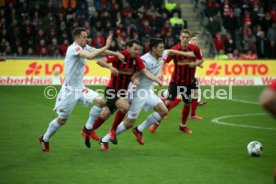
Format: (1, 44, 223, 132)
(101, 38, 194, 151)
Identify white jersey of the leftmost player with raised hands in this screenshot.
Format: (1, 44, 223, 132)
(63, 42, 95, 90)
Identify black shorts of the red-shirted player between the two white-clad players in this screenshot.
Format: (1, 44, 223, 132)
(104, 87, 127, 114)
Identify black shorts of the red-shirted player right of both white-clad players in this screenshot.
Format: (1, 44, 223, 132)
(167, 82, 193, 103)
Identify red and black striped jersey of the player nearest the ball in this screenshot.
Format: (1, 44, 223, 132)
(165, 43, 202, 85)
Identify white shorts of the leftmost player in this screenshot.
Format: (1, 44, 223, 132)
(54, 86, 100, 119)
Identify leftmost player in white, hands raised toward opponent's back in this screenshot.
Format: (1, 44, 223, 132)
(39, 28, 124, 152)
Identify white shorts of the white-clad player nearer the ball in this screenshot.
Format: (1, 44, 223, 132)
(127, 89, 163, 119)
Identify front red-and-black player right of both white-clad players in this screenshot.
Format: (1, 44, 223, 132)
(150, 29, 203, 134)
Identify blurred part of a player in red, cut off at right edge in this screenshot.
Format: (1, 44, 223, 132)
(260, 80, 276, 118)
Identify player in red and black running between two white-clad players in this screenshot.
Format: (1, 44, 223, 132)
(82, 40, 162, 148)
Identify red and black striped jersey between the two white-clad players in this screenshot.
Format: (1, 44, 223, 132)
(107, 50, 145, 91)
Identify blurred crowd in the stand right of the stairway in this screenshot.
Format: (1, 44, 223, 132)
(197, 0, 276, 59)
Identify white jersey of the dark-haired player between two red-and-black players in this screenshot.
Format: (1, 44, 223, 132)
(138, 51, 168, 89)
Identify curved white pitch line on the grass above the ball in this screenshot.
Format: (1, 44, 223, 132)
(211, 113, 276, 130)
